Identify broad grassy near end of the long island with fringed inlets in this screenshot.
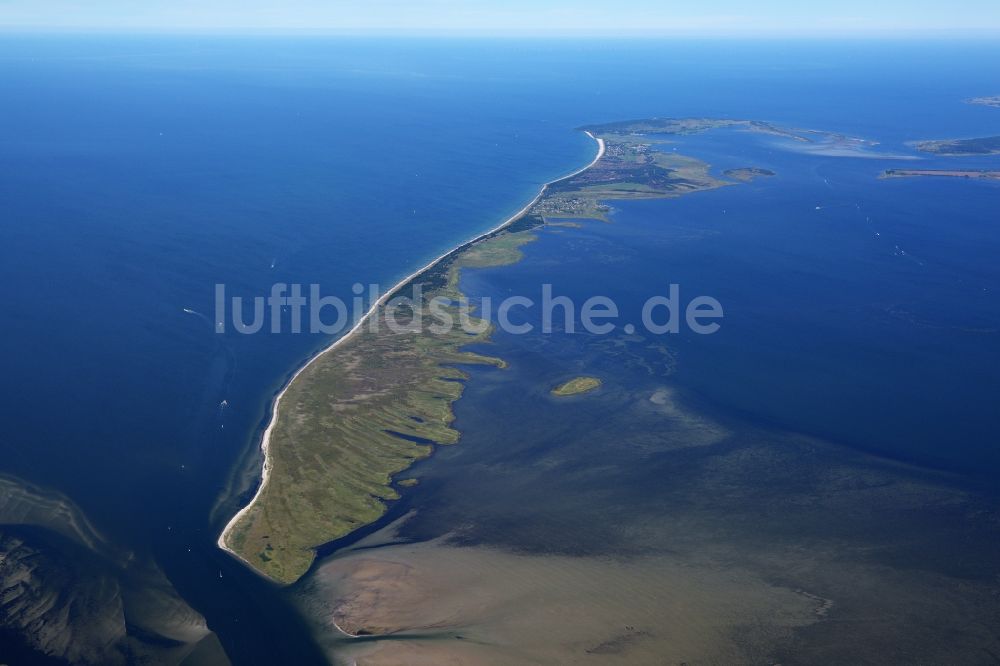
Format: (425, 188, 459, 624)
(226, 249, 504, 583)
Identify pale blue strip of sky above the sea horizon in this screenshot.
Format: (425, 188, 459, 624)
(0, 0, 1000, 36)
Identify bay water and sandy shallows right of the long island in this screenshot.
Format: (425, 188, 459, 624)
(296, 123, 1000, 665)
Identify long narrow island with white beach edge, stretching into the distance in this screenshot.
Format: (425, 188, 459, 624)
(218, 118, 796, 584)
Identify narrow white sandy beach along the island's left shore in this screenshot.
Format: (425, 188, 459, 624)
(216, 131, 605, 578)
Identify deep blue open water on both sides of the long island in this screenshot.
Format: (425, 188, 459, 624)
(0, 36, 1000, 664)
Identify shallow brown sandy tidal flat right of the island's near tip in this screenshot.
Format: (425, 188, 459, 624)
(299, 376, 1000, 665)
